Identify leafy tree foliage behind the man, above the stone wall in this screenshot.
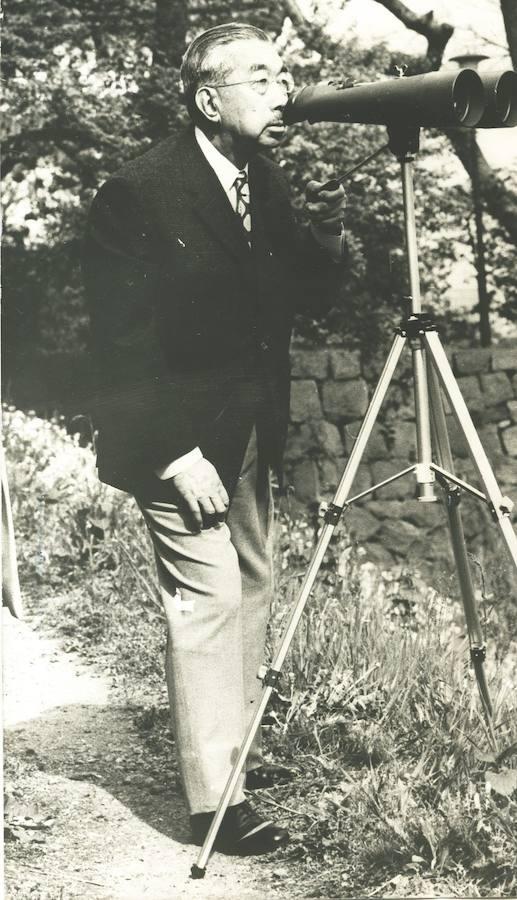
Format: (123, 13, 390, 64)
(2, 0, 507, 372)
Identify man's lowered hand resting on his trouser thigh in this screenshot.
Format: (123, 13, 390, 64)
(171, 458, 230, 531)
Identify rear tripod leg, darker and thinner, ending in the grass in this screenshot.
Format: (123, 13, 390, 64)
(428, 362, 492, 730)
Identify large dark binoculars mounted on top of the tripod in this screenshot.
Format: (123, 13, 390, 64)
(284, 69, 517, 128)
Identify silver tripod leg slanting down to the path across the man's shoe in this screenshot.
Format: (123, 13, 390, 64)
(191, 334, 406, 878)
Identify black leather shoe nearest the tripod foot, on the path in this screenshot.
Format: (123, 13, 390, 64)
(190, 800, 289, 856)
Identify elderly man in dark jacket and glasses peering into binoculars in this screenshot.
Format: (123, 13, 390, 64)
(85, 23, 345, 854)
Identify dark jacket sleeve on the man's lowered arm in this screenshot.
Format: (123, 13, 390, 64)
(83, 177, 203, 469)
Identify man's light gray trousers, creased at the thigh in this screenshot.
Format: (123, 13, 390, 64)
(139, 430, 273, 814)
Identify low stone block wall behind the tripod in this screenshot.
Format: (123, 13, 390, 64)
(286, 341, 517, 566)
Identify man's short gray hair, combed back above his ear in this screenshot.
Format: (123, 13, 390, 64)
(180, 22, 271, 126)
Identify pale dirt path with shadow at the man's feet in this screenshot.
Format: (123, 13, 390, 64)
(3, 611, 287, 900)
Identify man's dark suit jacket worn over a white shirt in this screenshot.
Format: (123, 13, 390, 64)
(84, 128, 343, 500)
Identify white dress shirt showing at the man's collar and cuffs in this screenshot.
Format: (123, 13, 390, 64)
(155, 125, 345, 480)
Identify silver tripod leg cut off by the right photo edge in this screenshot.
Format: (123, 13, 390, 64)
(424, 331, 517, 568)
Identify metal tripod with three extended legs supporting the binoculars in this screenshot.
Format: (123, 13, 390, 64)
(191, 128, 517, 878)
